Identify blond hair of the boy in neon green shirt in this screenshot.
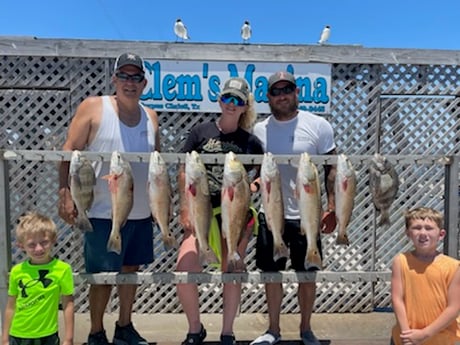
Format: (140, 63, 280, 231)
(16, 211, 57, 244)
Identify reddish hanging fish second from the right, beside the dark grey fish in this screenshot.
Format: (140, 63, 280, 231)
(334, 154, 356, 245)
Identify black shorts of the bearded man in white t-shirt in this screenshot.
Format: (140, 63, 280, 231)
(256, 213, 323, 272)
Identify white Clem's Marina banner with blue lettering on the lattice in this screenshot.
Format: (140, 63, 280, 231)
(141, 60, 331, 114)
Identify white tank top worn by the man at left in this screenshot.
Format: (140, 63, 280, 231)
(87, 96, 155, 219)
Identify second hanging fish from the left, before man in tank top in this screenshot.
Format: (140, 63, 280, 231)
(103, 151, 134, 254)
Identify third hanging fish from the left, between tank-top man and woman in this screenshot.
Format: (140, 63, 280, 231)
(148, 151, 177, 249)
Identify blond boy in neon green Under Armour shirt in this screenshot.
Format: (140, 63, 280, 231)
(2, 212, 74, 345)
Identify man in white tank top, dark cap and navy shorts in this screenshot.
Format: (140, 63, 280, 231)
(59, 53, 160, 345)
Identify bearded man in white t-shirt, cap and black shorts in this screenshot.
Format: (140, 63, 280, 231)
(251, 71, 336, 345)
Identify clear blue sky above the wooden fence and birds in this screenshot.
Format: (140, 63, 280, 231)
(0, 0, 460, 50)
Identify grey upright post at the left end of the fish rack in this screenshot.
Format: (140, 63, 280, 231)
(0, 153, 11, 329)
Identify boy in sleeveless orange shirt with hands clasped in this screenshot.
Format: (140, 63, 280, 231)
(391, 207, 460, 345)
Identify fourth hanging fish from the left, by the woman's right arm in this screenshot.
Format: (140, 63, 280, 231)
(185, 151, 218, 265)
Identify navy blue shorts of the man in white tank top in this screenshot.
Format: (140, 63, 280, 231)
(84, 217, 153, 273)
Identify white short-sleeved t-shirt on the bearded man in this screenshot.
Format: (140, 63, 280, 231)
(254, 111, 335, 219)
